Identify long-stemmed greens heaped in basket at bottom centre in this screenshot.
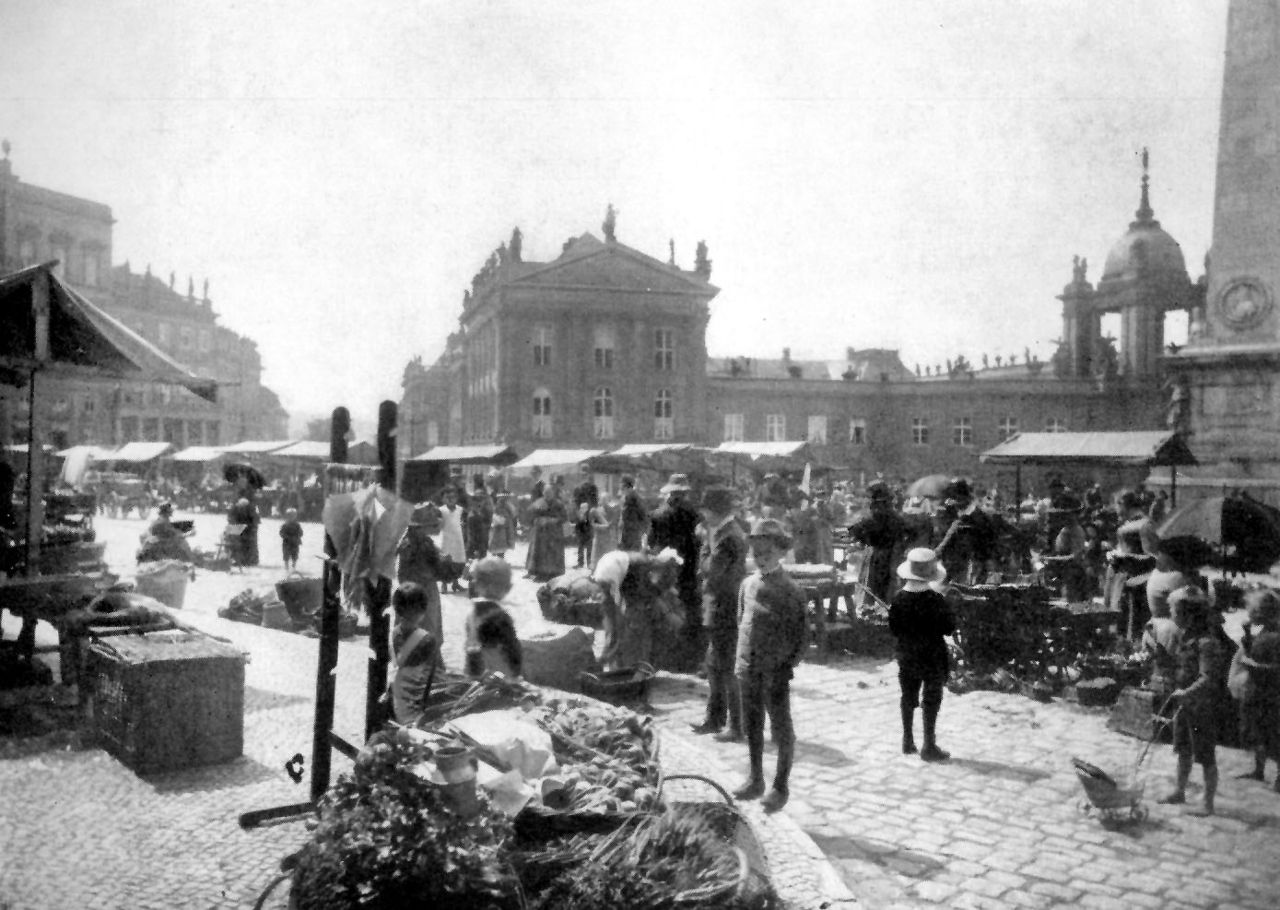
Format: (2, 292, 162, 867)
(524, 811, 772, 910)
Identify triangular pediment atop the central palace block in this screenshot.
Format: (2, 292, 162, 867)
(508, 241, 719, 297)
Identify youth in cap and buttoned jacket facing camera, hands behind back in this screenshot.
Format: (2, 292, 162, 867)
(733, 518, 806, 811)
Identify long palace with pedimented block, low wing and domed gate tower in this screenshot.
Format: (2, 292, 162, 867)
(401, 170, 1204, 480)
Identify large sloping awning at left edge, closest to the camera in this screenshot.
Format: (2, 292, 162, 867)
(0, 255, 218, 402)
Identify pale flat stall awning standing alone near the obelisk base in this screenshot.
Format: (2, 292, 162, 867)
(979, 430, 1197, 466)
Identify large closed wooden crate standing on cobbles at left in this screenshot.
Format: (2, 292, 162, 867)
(86, 632, 244, 774)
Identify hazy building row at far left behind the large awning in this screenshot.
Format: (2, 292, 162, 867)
(0, 147, 288, 448)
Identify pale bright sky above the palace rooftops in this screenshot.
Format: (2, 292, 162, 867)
(0, 0, 1226, 425)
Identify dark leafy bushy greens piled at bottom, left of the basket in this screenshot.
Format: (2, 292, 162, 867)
(291, 737, 520, 910)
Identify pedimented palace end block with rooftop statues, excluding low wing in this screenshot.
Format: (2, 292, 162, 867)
(399, 220, 718, 463)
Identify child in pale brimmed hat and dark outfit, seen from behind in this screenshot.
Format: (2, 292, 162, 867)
(888, 547, 956, 762)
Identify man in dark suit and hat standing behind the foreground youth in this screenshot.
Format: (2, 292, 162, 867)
(694, 486, 746, 742)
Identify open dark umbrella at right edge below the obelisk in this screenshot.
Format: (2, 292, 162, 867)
(1158, 497, 1280, 572)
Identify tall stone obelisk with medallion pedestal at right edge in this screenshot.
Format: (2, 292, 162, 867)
(1165, 0, 1280, 498)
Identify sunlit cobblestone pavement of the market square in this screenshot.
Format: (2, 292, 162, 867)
(0, 516, 1280, 910)
